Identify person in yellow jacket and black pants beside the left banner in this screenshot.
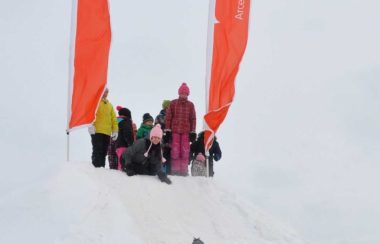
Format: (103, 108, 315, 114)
(88, 88, 119, 168)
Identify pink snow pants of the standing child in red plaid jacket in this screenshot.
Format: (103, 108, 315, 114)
(170, 133, 190, 176)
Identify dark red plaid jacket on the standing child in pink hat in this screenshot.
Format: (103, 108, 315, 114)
(165, 99, 197, 134)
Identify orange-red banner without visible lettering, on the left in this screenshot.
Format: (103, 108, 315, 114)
(69, 0, 111, 129)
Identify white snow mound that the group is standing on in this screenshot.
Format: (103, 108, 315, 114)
(0, 162, 305, 244)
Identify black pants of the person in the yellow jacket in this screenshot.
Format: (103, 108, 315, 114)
(91, 133, 110, 168)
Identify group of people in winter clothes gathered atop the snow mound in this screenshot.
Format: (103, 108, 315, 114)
(89, 83, 222, 184)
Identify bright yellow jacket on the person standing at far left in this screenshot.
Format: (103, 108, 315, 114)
(94, 98, 119, 136)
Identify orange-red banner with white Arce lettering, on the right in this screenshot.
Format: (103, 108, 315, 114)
(204, 0, 250, 150)
